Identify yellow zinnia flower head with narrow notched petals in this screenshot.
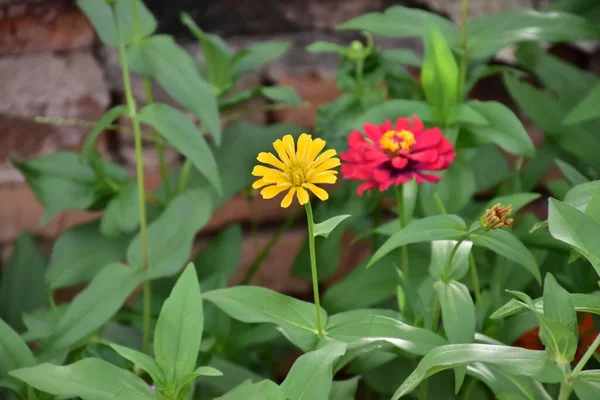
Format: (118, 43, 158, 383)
(252, 133, 340, 208)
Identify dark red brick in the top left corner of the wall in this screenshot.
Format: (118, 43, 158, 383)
(0, 2, 95, 54)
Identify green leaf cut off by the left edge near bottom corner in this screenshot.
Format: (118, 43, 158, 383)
(0, 319, 36, 395)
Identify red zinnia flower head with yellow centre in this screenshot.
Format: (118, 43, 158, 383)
(340, 117, 456, 196)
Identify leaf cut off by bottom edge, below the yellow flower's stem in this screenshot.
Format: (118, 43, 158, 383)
(281, 342, 346, 400)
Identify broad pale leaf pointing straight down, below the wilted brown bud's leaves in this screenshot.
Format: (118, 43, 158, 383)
(433, 281, 475, 343)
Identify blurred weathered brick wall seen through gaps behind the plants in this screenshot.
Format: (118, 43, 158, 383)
(0, 0, 600, 293)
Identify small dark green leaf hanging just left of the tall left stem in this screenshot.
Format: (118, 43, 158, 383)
(100, 181, 140, 238)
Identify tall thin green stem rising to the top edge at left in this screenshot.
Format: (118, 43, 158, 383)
(115, 0, 151, 354)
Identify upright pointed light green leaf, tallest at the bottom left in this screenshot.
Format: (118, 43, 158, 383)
(154, 263, 204, 385)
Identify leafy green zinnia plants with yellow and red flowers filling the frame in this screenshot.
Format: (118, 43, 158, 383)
(0, 0, 600, 400)
